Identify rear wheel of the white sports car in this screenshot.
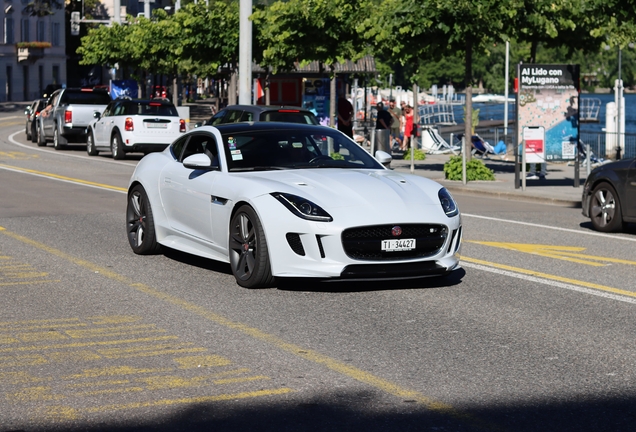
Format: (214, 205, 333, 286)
(126, 185, 161, 255)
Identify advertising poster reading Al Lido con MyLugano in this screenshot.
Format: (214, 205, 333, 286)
(517, 64, 579, 163)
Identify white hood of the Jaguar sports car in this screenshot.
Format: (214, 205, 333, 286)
(236, 168, 442, 211)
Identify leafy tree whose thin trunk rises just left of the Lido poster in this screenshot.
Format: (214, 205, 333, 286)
(359, 0, 521, 159)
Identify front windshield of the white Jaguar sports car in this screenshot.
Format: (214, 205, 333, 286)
(223, 128, 382, 171)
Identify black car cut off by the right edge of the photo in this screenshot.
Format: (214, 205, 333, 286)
(581, 158, 636, 232)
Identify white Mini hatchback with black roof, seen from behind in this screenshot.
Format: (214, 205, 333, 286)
(86, 98, 186, 159)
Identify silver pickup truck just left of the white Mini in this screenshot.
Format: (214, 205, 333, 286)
(37, 88, 110, 150)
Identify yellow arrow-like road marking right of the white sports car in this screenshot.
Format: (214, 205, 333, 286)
(465, 240, 636, 267)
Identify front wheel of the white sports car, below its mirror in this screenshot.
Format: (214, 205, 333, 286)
(229, 205, 274, 288)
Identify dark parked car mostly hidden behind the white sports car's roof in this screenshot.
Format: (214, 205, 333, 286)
(195, 105, 319, 127)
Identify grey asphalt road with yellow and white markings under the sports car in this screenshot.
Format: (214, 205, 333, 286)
(0, 112, 636, 432)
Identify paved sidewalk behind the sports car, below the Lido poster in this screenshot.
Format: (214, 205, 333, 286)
(391, 153, 587, 208)
